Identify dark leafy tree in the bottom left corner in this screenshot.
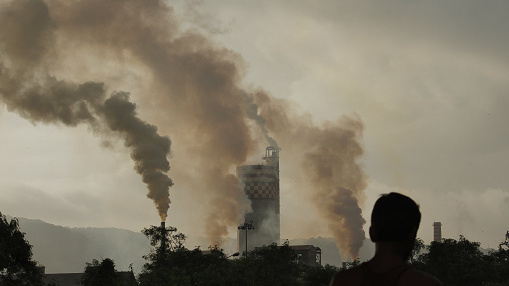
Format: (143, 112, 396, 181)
(0, 213, 43, 286)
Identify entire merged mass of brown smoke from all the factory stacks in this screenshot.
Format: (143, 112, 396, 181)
(0, 0, 365, 253)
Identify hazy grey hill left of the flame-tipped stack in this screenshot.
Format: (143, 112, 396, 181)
(13, 218, 150, 273)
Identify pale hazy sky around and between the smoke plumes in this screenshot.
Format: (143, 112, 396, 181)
(0, 0, 509, 250)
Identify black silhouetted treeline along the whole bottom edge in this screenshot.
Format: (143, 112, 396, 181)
(0, 213, 509, 286)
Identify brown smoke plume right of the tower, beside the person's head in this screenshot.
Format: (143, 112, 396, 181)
(256, 92, 367, 258)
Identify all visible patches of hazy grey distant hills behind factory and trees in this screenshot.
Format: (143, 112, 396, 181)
(11, 218, 374, 274)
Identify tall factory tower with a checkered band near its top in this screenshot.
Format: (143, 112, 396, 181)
(237, 146, 280, 253)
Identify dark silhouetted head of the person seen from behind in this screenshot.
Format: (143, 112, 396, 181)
(369, 193, 421, 243)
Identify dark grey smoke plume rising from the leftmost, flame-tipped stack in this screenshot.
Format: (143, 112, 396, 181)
(0, 0, 172, 220)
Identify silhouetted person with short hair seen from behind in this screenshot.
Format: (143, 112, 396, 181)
(330, 193, 442, 286)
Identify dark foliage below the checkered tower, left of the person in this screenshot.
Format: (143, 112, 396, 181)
(138, 227, 337, 286)
